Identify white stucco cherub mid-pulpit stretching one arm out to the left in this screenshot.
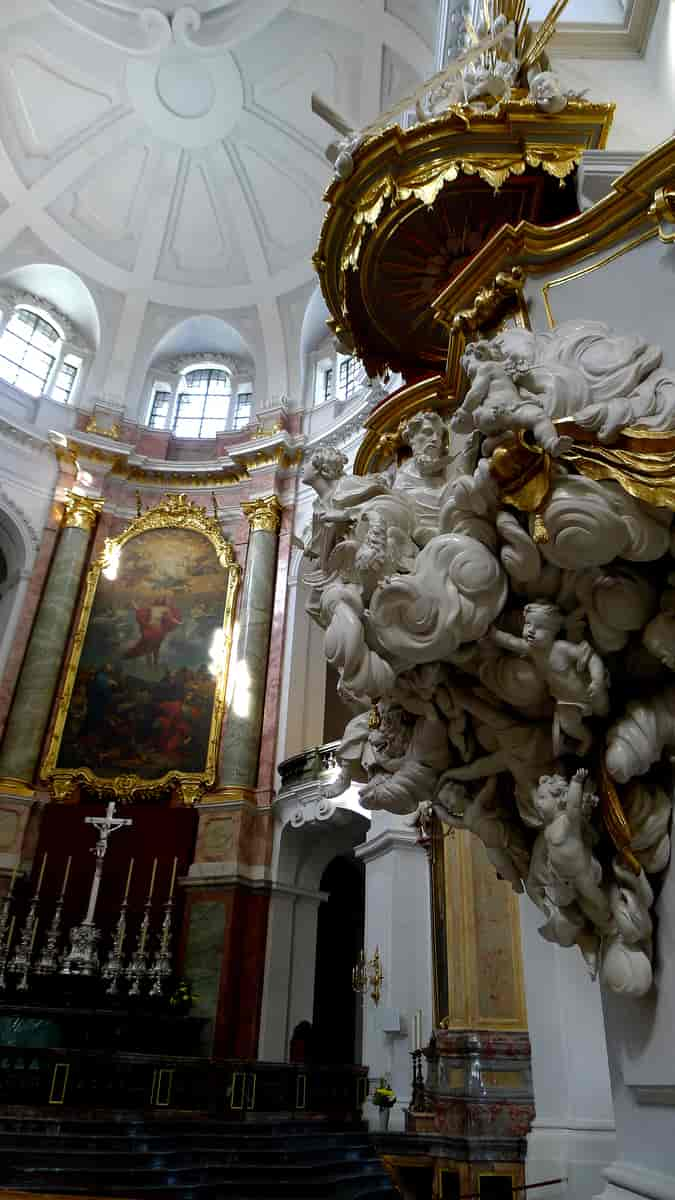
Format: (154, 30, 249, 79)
(486, 601, 609, 756)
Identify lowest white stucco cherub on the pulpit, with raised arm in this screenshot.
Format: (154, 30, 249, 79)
(533, 768, 611, 931)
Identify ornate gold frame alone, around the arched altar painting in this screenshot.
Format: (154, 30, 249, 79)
(41, 493, 241, 804)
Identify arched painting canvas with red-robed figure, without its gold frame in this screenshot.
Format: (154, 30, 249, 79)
(56, 529, 227, 780)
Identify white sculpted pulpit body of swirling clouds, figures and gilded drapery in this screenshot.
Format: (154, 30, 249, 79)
(300, 320, 675, 996)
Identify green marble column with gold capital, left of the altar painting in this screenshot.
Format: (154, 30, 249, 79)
(0, 492, 103, 792)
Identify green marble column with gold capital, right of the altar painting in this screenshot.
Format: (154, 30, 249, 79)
(217, 496, 281, 799)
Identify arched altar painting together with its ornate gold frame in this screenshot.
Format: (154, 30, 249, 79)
(41, 494, 241, 804)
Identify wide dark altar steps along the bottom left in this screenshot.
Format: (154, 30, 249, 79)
(0, 1117, 398, 1200)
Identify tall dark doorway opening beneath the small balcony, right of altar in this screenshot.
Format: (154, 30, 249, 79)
(313, 858, 364, 1063)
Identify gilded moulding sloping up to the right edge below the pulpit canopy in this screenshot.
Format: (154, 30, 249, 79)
(434, 137, 675, 328)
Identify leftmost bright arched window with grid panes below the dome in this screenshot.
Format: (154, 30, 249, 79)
(0, 305, 82, 403)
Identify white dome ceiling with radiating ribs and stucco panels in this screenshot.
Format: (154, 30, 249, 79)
(0, 0, 429, 410)
